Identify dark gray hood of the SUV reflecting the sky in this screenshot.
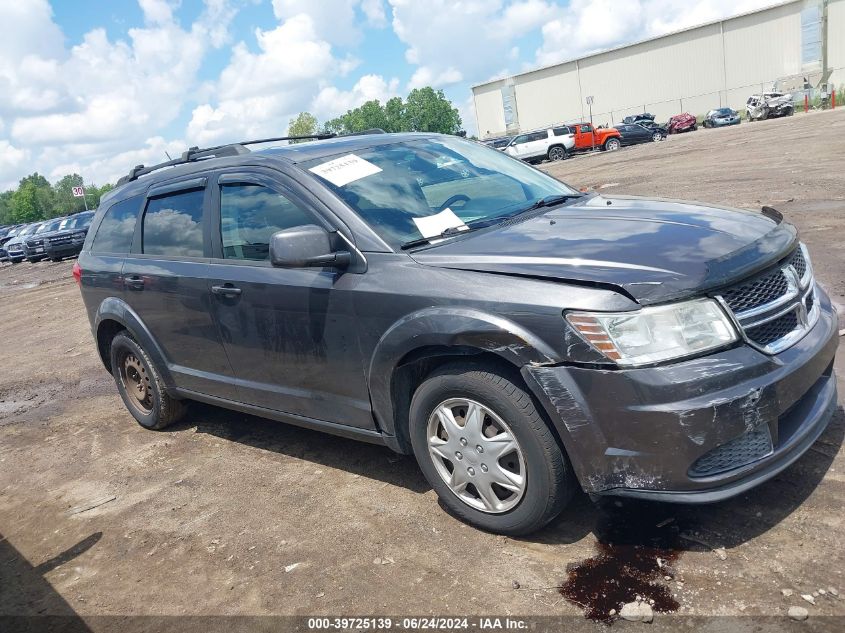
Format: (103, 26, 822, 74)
(411, 195, 797, 305)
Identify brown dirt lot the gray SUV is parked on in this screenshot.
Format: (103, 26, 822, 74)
(0, 109, 845, 631)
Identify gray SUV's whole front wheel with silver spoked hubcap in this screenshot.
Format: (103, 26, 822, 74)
(410, 362, 575, 536)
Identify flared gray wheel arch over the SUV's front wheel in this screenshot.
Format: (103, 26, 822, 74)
(368, 307, 559, 436)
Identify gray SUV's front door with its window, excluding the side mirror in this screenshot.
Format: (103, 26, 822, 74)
(207, 170, 375, 429)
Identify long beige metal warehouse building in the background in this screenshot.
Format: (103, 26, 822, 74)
(472, 0, 845, 138)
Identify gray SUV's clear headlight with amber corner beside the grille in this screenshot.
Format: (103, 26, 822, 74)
(566, 299, 737, 366)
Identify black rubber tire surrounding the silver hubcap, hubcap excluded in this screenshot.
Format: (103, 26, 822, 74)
(410, 368, 568, 535)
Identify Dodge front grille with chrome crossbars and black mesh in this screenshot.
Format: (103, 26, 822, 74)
(719, 245, 819, 354)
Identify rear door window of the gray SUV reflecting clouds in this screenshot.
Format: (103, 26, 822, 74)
(143, 189, 205, 257)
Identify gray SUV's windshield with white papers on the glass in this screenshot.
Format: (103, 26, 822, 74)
(302, 136, 580, 246)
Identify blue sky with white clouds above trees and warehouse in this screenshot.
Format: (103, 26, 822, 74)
(0, 0, 772, 190)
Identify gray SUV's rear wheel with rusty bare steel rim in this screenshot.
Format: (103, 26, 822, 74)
(111, 332, 185, 431)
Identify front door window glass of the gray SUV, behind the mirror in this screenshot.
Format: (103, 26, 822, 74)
(220, 185, 314, 261)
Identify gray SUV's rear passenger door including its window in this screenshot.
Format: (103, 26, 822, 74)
(123, 177, 237, 399)
